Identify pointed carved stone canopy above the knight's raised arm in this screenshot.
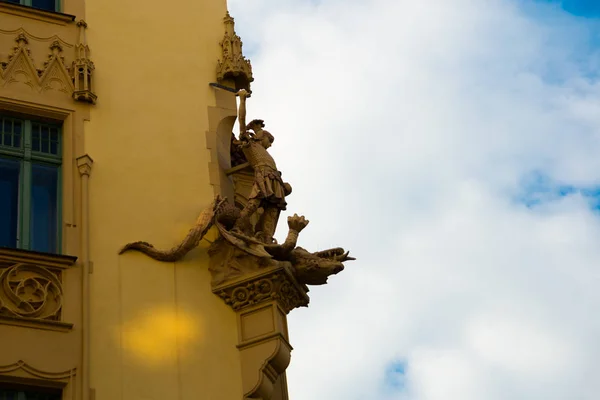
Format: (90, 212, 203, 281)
(217, 12, 254, 91)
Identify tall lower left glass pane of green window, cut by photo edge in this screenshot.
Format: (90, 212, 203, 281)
(0, 158, 21, 247)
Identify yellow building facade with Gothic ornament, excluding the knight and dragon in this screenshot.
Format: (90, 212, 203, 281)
(0, 0, 349, 400)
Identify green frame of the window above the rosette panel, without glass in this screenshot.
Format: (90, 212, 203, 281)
(0, 113, 64, 254)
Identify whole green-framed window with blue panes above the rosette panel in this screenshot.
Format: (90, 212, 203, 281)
(0, 115, 61, 253)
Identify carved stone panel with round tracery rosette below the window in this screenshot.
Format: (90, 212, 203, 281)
(0, 263, 63, 321)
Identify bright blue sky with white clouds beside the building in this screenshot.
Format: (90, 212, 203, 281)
(228, 0, 600, 400)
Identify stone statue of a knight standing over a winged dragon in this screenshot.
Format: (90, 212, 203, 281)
(119, 89, 354, 287)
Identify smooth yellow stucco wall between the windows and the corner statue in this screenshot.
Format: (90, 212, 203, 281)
(84, 0, 242, 400)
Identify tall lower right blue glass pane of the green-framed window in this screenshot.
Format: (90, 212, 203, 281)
(30, 164, 58, 253)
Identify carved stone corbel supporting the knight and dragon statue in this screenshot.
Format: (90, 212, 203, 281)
(213, 263, 309, 400)
